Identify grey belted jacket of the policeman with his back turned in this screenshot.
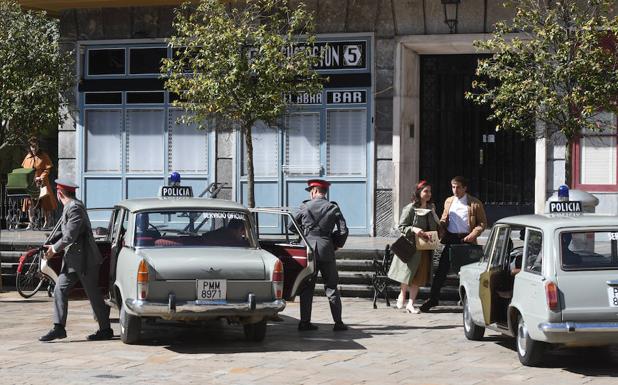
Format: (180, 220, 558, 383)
(295, 198, 348, 261)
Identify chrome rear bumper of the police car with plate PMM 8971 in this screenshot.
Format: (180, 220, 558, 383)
(125, 295, 285, 320)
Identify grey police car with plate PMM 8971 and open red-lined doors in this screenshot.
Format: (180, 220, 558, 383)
(99, 197, 315, 344)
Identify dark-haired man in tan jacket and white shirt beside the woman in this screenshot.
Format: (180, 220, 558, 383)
(420, 176, 487, 312)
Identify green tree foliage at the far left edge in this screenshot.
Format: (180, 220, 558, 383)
(0, 0, 73, 149)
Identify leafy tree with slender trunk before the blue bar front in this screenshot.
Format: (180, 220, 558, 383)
(162, 0, 321, 207)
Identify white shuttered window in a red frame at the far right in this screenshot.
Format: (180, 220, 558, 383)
(576, 113, 618, 186)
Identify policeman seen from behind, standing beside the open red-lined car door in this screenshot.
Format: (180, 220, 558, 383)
(295, 179, 348, 331)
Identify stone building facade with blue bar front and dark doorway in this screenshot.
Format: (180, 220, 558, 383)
(21, 0, 618, 232)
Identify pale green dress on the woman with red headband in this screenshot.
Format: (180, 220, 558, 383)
(388, 203, 439, 285)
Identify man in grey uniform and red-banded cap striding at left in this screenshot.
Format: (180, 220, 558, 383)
(39, 180, 114, 342)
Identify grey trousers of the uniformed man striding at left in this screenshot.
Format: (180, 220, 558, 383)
(54, 265, 110, 330)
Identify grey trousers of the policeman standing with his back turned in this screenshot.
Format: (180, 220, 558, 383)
(300, 260, 342, 322)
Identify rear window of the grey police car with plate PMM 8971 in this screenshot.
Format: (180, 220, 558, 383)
(135, 210, 255, 247)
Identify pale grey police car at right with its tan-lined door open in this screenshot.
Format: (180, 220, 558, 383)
(459, 214, 618, 366)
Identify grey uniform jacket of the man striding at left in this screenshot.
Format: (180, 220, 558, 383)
(53, 199, 103, 274)
